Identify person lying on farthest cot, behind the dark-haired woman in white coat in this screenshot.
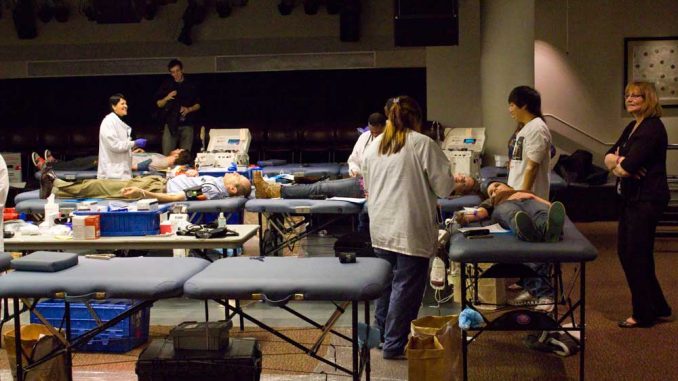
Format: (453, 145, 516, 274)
(31, 148, 192, 172)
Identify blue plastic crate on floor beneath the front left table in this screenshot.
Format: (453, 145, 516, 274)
(31, 299, 151, 353)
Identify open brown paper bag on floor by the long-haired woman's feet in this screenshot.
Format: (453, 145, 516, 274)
(405, 315, 461, 381)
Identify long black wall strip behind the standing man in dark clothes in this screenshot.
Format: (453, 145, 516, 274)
(0, 68, 426, 130)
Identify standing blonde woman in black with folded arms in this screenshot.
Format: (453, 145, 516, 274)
(605, 82, 671, 328)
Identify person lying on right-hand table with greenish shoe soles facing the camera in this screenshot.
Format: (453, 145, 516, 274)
(455, 181, 565, 242)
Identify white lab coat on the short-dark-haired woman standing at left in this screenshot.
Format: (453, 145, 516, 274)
(97, 112, 134, 179)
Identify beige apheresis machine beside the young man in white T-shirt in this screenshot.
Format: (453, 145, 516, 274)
(442, 127, 485, 179)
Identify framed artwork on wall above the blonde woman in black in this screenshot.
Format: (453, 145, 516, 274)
(624, 36, 678, 107)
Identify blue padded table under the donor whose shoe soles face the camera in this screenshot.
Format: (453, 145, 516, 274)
(449, 219, 598, 380)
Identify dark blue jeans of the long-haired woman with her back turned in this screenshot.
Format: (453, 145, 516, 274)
(374, 249, 429, 355)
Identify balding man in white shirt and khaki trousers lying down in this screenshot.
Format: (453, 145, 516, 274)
(40, 169, 252, 203)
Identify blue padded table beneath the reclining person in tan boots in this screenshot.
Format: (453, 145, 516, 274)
(245, 198, 363, 256)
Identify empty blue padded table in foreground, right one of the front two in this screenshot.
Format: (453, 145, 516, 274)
(184, 257, 391, 380)
